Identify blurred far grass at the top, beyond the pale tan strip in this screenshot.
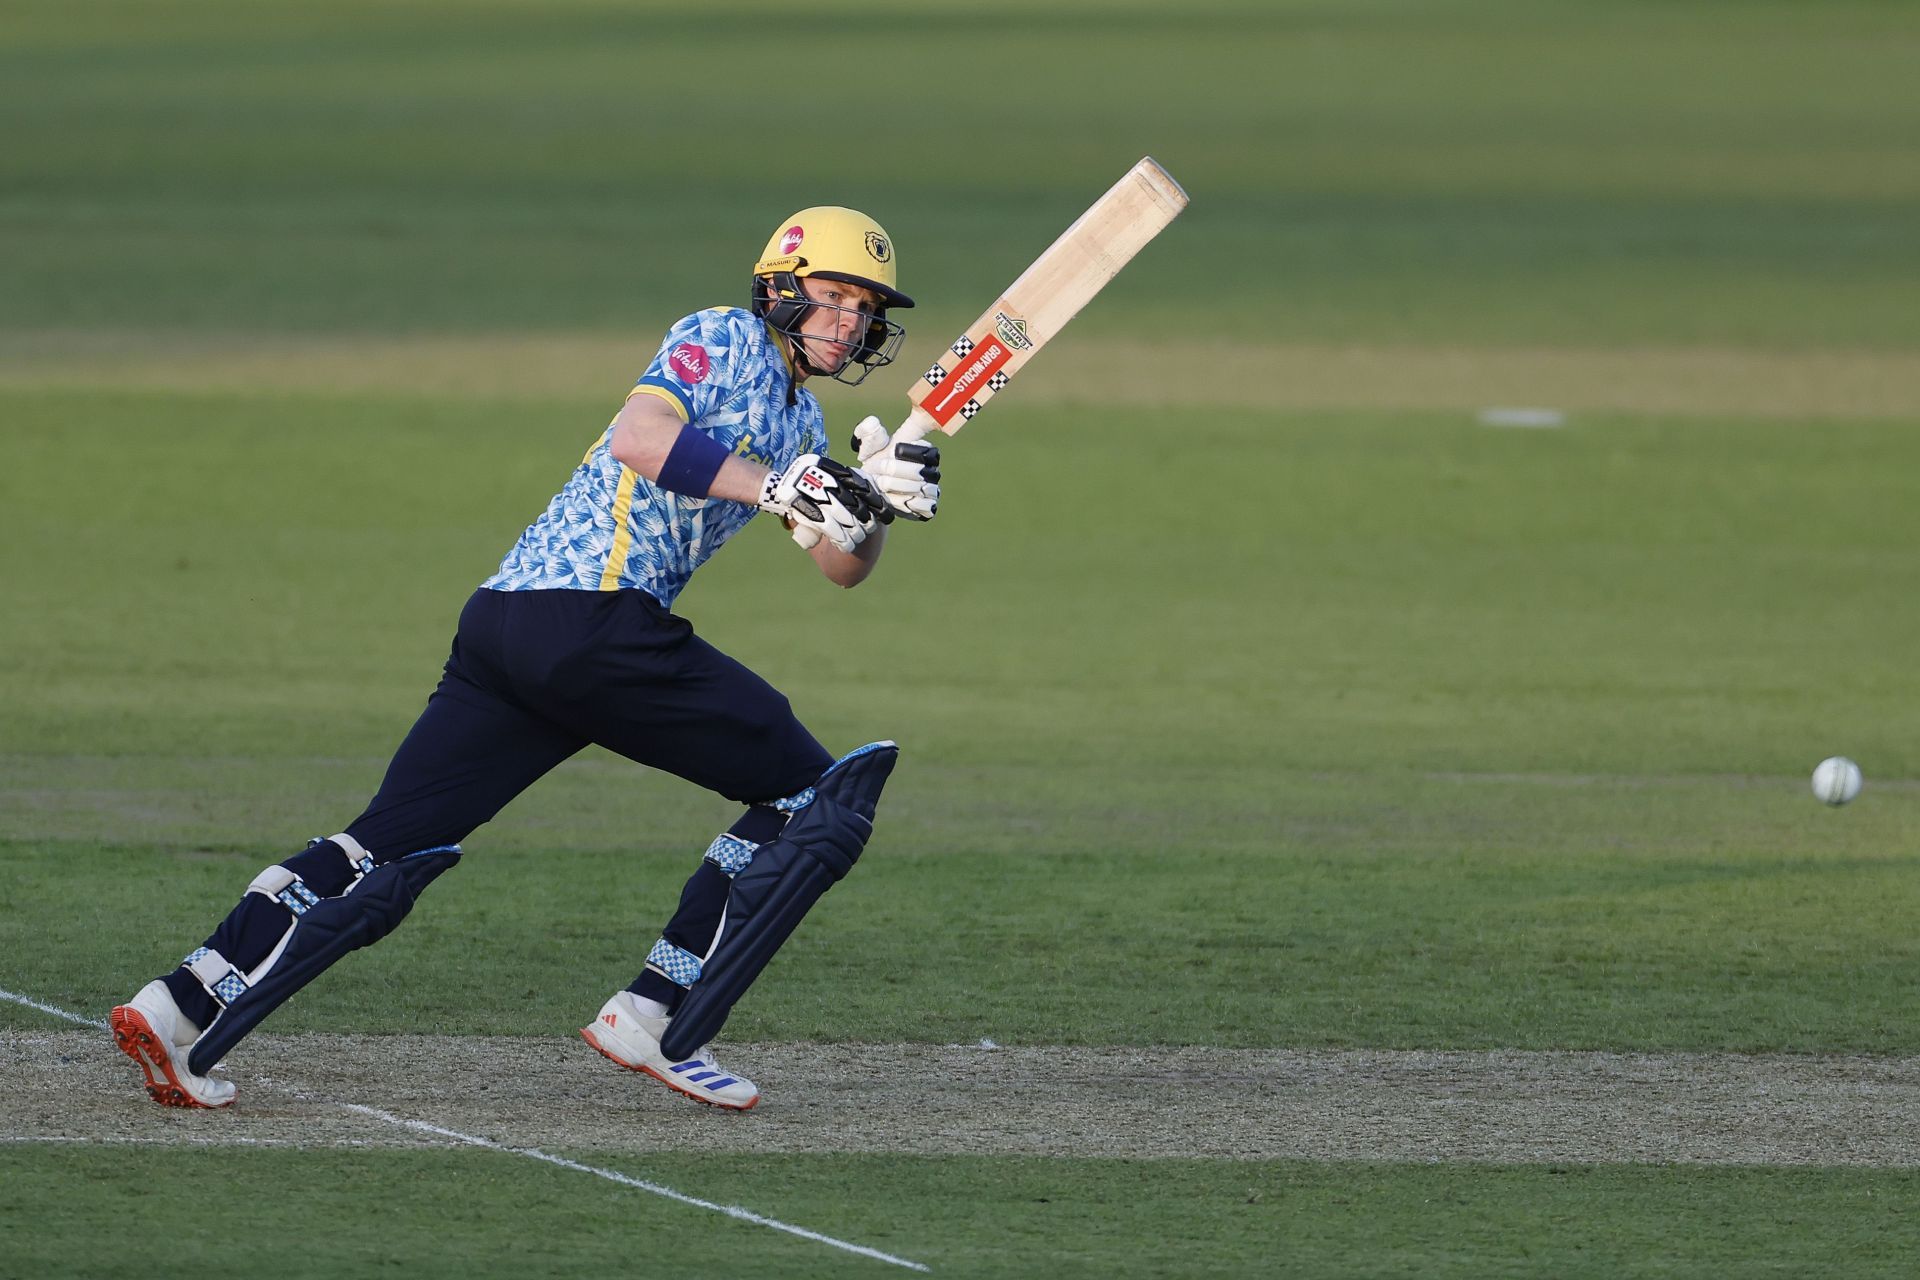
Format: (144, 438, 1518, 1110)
(15, 0, 1920, 370)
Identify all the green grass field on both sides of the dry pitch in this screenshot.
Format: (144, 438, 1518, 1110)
(0, 0, 1920, 1276)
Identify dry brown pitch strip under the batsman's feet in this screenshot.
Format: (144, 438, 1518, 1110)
(0, 1031, 1920, 1167)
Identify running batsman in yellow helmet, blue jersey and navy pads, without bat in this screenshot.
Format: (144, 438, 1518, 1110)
(111, 207, 939, 1111)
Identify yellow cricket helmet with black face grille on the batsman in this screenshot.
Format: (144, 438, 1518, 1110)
(753, 205, 914, 386)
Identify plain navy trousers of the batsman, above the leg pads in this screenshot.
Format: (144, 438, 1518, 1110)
(348, 587, 833, 862)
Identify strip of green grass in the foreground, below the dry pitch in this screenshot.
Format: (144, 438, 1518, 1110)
(0, 1150, 1920, 1280)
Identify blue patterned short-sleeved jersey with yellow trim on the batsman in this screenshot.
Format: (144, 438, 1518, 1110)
(480, 307, 828, 606)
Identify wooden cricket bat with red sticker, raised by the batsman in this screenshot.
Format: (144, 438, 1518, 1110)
(893, 155, 1187, 441)
